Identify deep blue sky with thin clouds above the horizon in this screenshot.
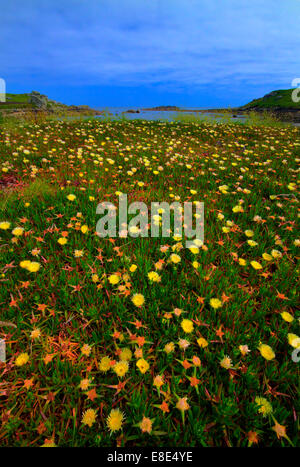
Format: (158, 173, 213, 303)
(0, 0, 300, 107)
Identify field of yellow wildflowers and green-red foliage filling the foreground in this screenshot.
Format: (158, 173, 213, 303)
(0, 119, 300, 447)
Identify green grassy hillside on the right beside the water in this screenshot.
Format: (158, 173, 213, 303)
(239, 89, 300, 111)
